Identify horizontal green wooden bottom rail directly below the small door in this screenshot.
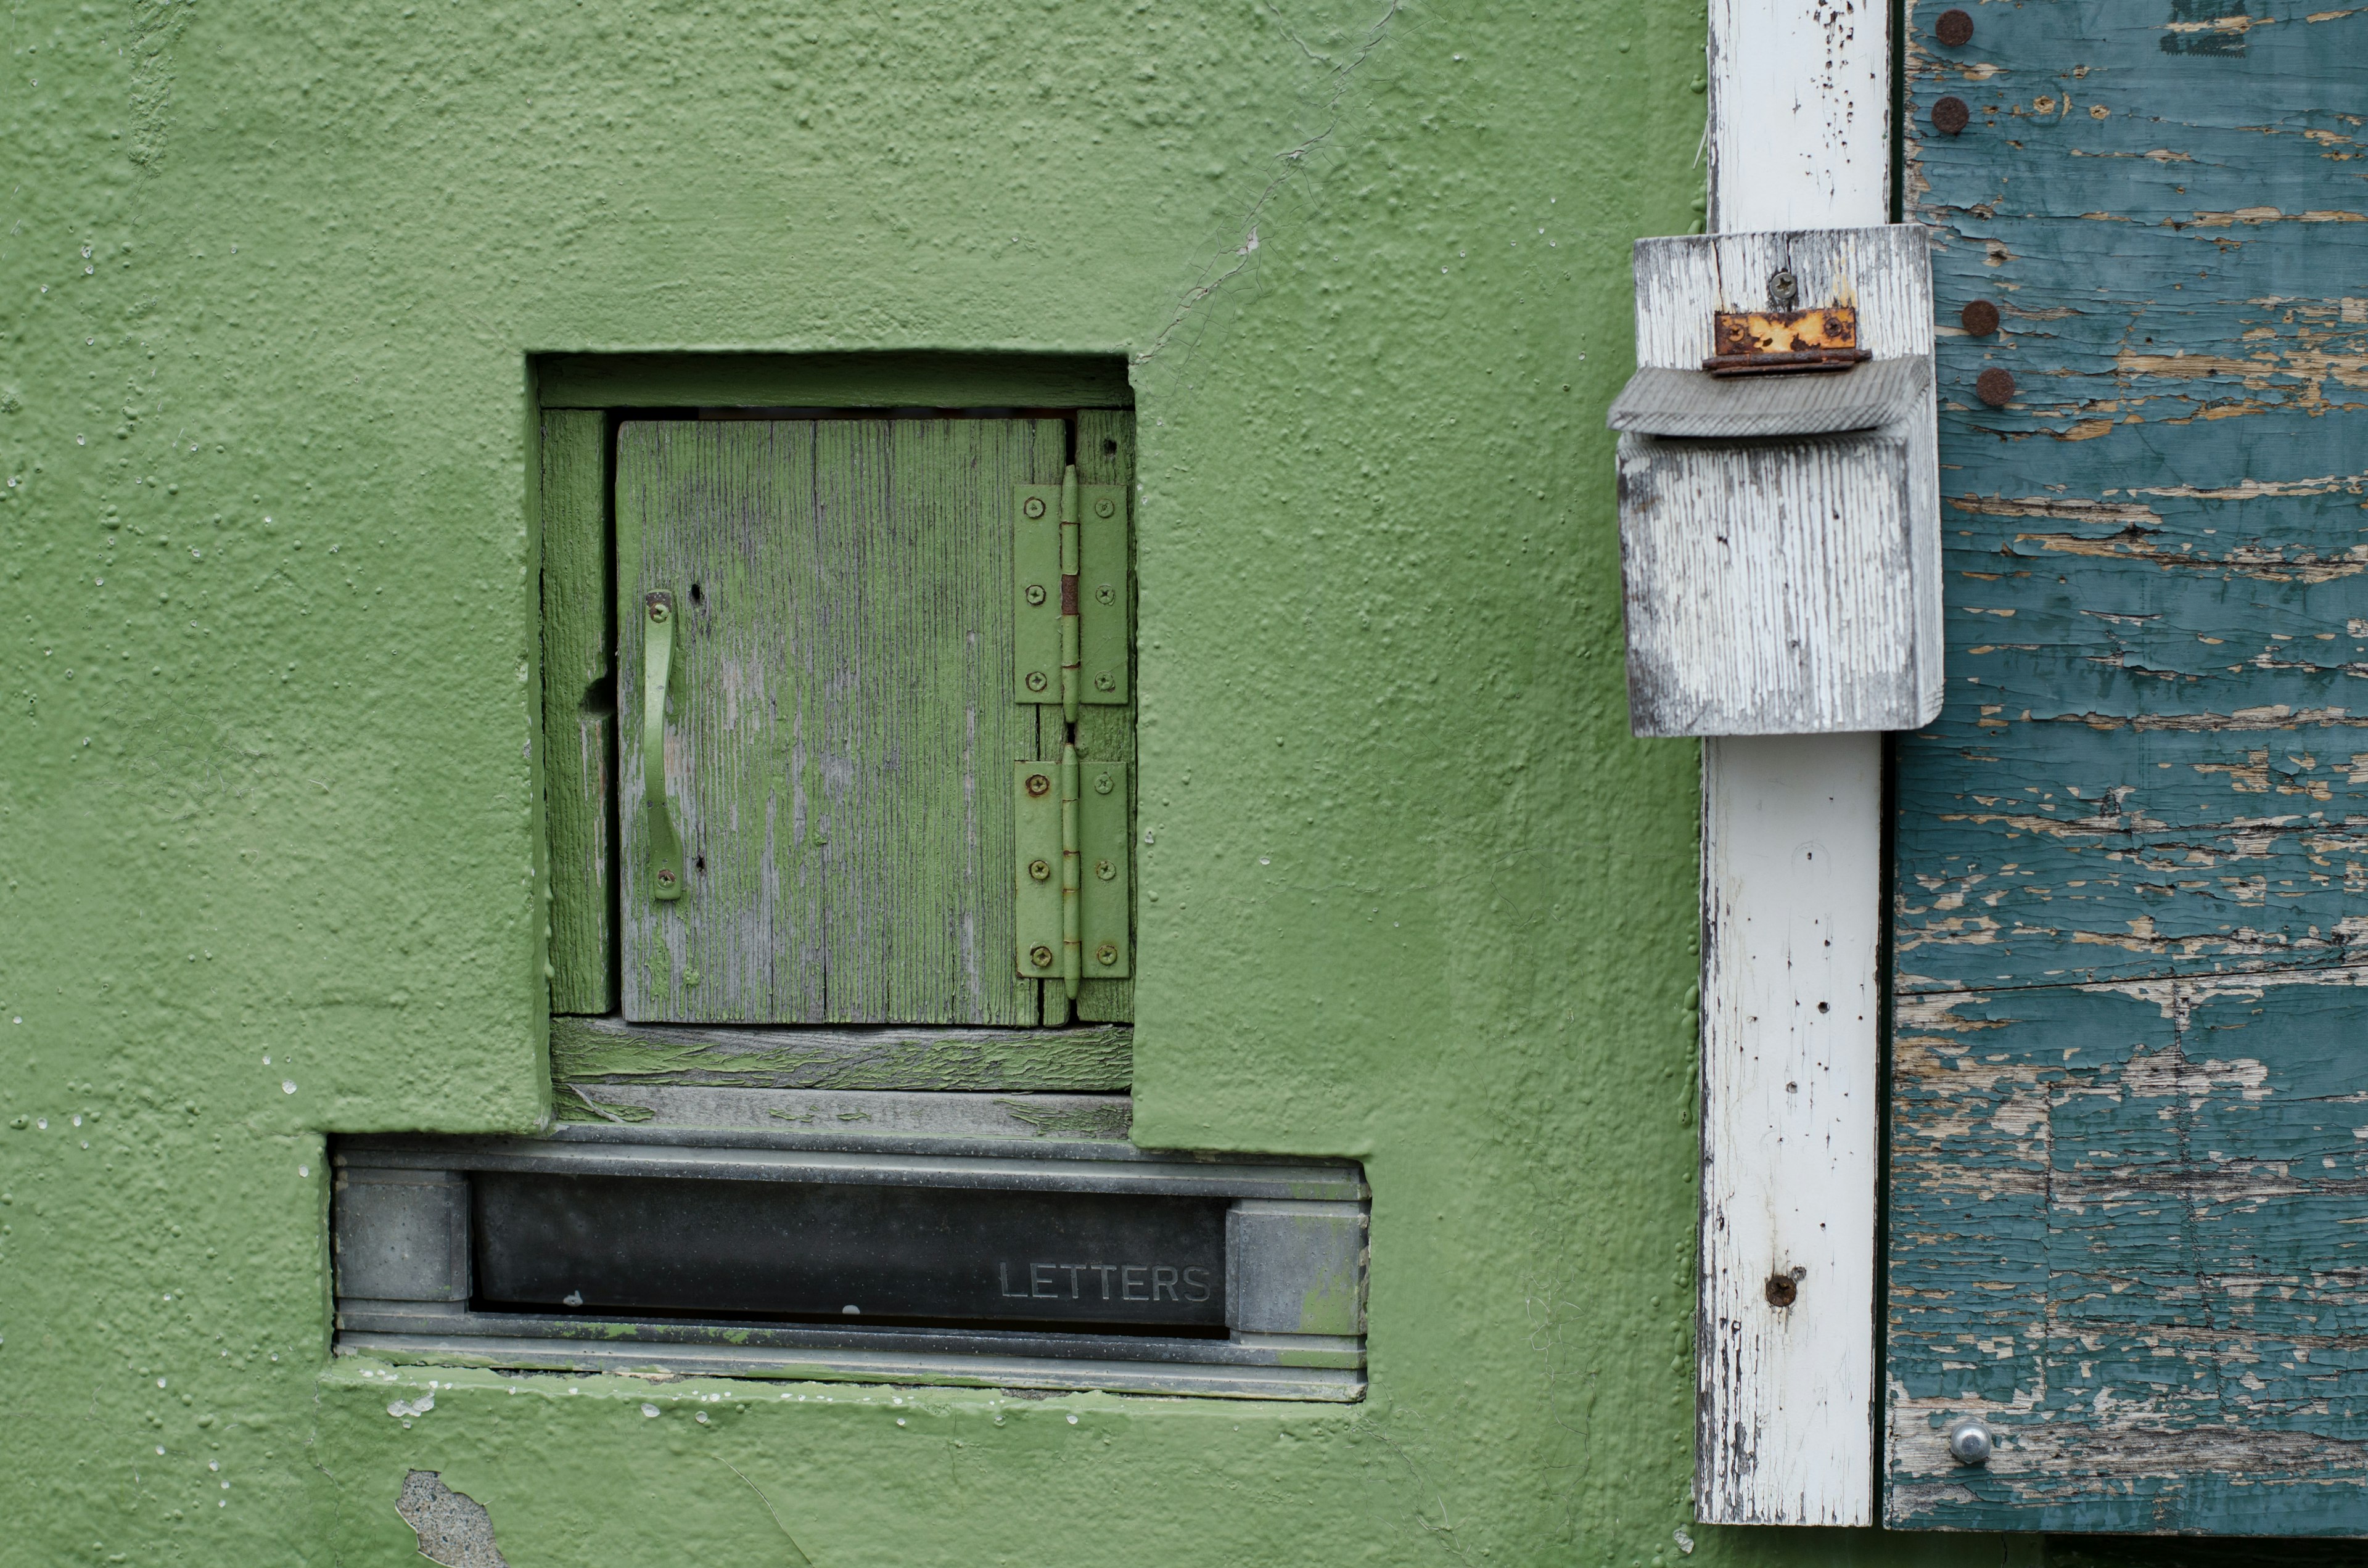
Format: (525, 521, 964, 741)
(552, 1019, 1134, 1094)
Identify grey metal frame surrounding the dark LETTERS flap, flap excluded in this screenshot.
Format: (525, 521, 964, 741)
(332, 1128, 1371, 1402)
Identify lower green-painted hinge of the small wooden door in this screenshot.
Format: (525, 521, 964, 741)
(1011, 746, 1134, 997)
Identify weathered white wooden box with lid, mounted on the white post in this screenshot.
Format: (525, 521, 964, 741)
(1610, 225, 1942, 734)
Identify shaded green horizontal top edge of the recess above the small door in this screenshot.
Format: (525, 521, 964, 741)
(535, 353, 1134, 412)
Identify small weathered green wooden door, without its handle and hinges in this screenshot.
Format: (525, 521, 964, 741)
(615, 419, 1068, 1025)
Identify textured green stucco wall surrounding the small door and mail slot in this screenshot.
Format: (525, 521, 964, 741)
(0, 0, 2055, 1568)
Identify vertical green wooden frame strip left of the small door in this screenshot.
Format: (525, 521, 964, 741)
(542, 410, 615, 1014)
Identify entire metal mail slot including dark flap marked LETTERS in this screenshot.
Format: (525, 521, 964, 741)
(332, 1128, 1369, 1402)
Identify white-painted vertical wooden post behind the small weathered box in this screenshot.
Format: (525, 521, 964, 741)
(1695, 0, 1892, 1525)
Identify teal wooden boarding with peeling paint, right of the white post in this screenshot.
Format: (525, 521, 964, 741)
(1887, 0, 2368, 1535)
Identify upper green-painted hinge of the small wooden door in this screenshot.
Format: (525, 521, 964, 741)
(1011, 467, 1134, 718)
